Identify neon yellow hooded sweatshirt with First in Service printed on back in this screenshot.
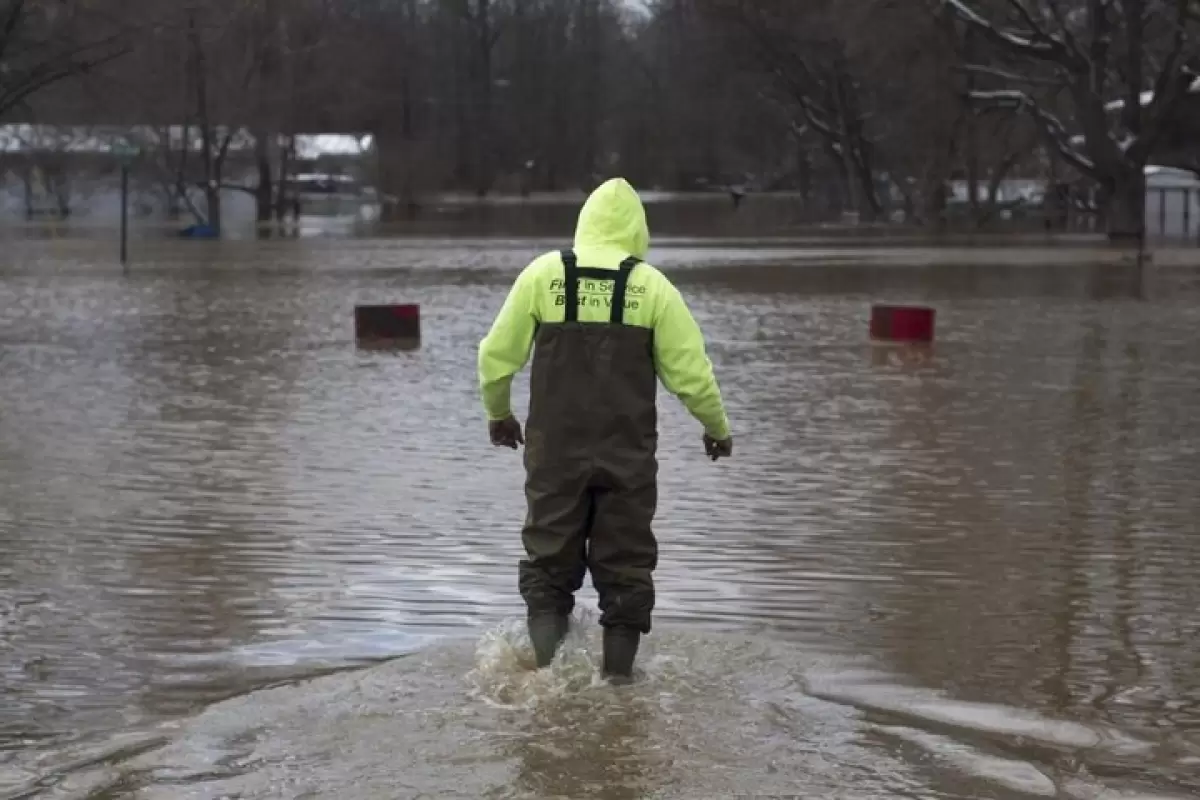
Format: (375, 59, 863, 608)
(479, 178, 730, 439)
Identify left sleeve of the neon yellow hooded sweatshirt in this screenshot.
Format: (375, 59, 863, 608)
(479, 265, 538, 421)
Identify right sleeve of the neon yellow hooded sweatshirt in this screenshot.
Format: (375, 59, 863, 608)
(654, 279, 730, 439)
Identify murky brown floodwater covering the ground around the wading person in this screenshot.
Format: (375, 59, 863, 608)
(0, 232, 1200, 800)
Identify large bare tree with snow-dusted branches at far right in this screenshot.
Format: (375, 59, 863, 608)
(937, 0, 1200, 242)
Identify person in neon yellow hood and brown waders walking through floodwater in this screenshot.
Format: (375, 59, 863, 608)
(479, 179, 733, 682)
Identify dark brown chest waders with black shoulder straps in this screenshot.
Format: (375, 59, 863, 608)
(518, 251, 658, 674)
